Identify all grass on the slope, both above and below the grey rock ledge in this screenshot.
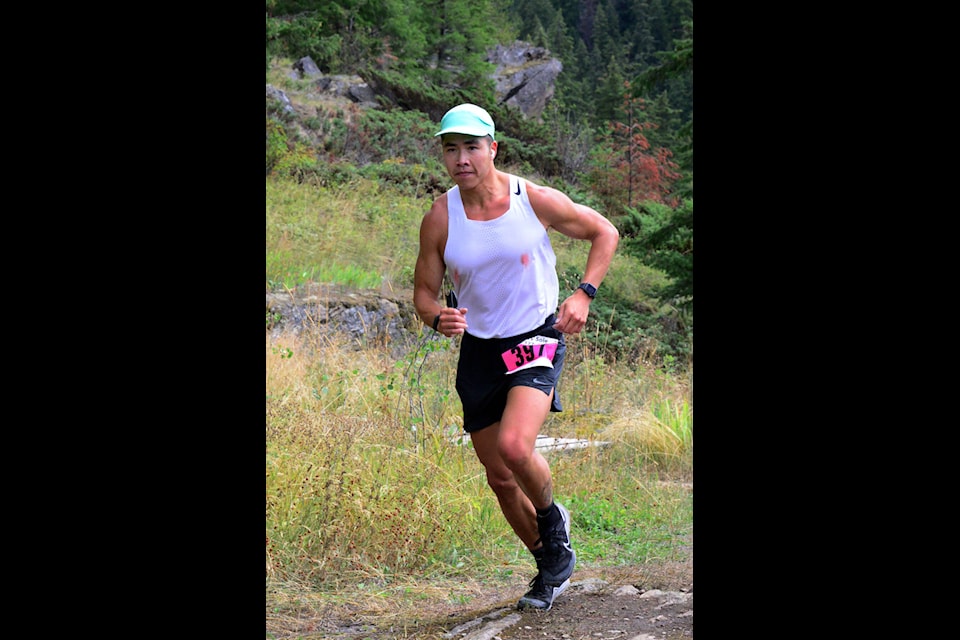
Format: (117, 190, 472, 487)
(265, 172, 693, 632)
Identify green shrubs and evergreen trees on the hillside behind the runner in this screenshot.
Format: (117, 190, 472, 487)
(266, 0, 693, 371)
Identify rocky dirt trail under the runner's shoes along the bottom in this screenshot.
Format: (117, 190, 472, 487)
(266, 552, 693, 640)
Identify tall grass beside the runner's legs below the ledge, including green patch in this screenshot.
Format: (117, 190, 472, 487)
(266, 320, 692, 590)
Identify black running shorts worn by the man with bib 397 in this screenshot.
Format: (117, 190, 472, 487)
(457, 315, 567, 433)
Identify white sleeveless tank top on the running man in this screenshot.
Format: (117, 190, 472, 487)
(443, 175, 560, 338)
